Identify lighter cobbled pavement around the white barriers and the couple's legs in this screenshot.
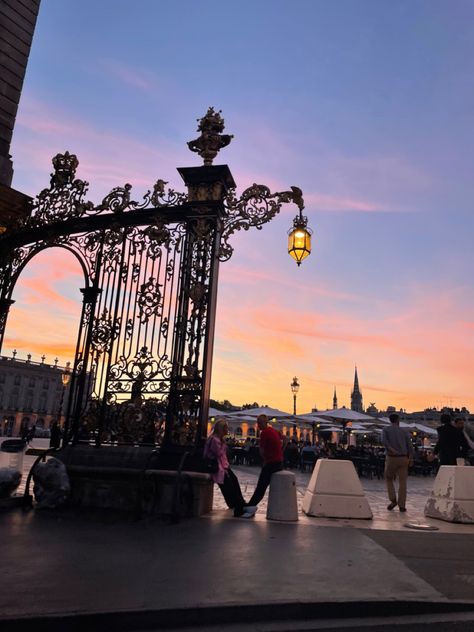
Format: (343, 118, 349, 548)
(211, 465, 474, 534)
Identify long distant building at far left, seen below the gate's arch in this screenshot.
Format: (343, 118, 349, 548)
(0, 352, 69, 436)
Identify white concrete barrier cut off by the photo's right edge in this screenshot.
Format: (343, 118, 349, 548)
(425, 465, 474, 523)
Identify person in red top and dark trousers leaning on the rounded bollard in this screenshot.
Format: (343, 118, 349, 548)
(245, 415, 283, 513)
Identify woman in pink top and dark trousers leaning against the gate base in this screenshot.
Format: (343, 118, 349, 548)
(204, 419, 255, 518)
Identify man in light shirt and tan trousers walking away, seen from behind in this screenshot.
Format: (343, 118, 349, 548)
(382, 413, 413, 512)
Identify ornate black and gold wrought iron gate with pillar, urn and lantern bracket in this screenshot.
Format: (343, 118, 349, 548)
(0, 108, 303, 446)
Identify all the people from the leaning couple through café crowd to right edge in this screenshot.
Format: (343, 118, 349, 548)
(204, 413, 474, 518)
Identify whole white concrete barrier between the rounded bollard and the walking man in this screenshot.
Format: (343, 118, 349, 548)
(303, 459, 372, 519)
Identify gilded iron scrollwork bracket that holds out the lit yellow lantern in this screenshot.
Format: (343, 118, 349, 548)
(219, 184, 304, 261)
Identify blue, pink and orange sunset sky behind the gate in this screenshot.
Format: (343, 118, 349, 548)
(3, 0, 474, 413)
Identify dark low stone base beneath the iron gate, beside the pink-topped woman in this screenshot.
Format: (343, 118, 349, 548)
(55, 446, 214, 517)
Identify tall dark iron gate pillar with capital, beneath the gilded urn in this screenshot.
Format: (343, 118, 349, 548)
(164, 165, 236, 452)
